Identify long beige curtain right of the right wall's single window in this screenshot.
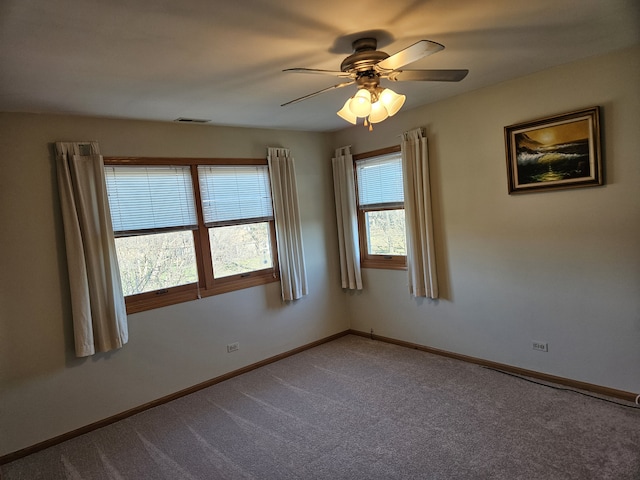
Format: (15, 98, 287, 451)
(401, 128, 438, 298)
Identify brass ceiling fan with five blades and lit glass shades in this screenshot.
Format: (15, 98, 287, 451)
(281, 37, 469, 130)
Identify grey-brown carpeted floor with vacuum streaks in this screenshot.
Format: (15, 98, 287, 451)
(2, 335, 640, 480)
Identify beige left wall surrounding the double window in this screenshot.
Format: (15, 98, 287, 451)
(0, 114, 349, 454)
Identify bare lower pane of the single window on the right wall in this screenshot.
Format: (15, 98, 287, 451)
(365, 209, 407, 255)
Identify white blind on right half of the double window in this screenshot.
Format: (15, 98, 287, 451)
(198, 165, 273, 227)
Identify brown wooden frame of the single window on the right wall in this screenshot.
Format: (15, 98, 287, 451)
(353, 145, 407, 270)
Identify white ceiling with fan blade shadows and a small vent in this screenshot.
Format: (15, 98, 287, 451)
(0, 0, 640, 131)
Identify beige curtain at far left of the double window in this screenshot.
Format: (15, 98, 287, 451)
(56, 142, 128, 357)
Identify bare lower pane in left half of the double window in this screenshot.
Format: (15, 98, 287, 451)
(116, 231, 198, 296)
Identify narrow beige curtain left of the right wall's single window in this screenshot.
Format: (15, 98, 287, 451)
(332, 146, 362, 290)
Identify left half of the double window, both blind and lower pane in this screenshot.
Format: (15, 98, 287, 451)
(105, 165, 198, 296)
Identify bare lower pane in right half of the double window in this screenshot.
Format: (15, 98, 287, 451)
(209, 222, 273, 278)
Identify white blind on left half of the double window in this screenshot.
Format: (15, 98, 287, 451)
(105, 165, 198, 236)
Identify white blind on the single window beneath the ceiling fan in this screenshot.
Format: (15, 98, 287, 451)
(356, 153, 404, 209)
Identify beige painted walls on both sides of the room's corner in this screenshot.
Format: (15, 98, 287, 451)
(0, 48, 640, 455)
